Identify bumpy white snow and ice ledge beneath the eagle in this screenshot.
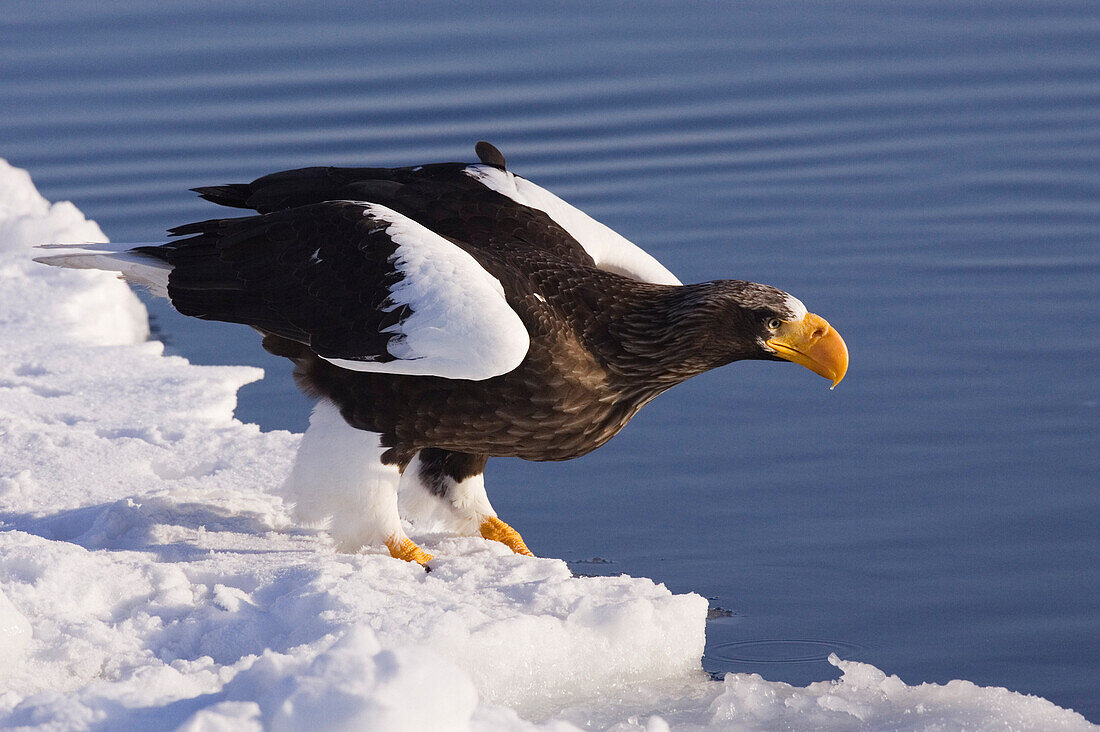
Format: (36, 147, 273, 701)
(0, 161, 1091, 731)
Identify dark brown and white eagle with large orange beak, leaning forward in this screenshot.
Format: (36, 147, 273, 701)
(37, 142, 848, 567)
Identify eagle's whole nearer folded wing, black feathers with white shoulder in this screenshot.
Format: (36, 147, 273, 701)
(157, 200, 530, 381)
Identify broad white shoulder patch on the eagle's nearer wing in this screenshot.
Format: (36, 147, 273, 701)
(326, 204, 530, 381)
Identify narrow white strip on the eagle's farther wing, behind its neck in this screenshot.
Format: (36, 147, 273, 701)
(464, 165, 683, 285)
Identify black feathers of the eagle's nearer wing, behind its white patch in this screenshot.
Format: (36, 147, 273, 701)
(148, 203, 408, 362)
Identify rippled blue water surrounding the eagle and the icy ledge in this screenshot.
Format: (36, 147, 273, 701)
(0, 0, 1100, 721)
